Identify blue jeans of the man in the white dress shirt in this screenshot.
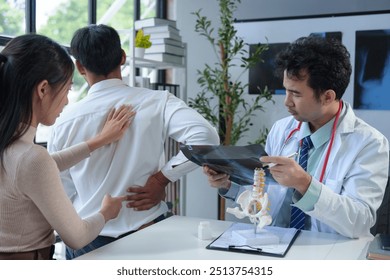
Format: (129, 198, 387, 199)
(66, 215, 165, 260)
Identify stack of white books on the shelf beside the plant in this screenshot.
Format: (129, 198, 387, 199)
(134, 18, 185, 65)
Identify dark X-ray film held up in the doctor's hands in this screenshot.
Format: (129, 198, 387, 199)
(180, 144, 267, 185)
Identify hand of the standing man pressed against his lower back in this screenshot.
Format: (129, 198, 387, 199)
(126, 171, 170, 211)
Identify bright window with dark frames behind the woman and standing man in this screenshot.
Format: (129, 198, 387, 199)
(0, 0, 166, 143)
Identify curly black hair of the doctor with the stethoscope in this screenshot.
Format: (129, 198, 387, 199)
(276, 35, 352, 99)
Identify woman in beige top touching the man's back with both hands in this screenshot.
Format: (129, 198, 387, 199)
(0, 34, 134, 259)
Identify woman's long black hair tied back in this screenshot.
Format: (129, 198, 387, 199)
(0, 34, 74, 166)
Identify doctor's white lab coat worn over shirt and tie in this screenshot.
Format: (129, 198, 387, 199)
(266, 102, 389, 238)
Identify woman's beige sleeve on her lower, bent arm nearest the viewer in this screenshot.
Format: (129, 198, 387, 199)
(17, 147, 105, 249)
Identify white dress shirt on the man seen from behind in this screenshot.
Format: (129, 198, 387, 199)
(48, 79, 219, 237)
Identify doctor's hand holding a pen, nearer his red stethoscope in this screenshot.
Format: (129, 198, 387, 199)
(260, 156, 311, 195)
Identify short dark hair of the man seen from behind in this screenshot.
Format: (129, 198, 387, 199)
(70, 24, 122, 76)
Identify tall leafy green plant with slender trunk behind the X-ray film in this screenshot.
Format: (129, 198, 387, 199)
(188, 0, 274, 220)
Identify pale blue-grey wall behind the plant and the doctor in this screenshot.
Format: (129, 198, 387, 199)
(176, 0, 390, 218)
